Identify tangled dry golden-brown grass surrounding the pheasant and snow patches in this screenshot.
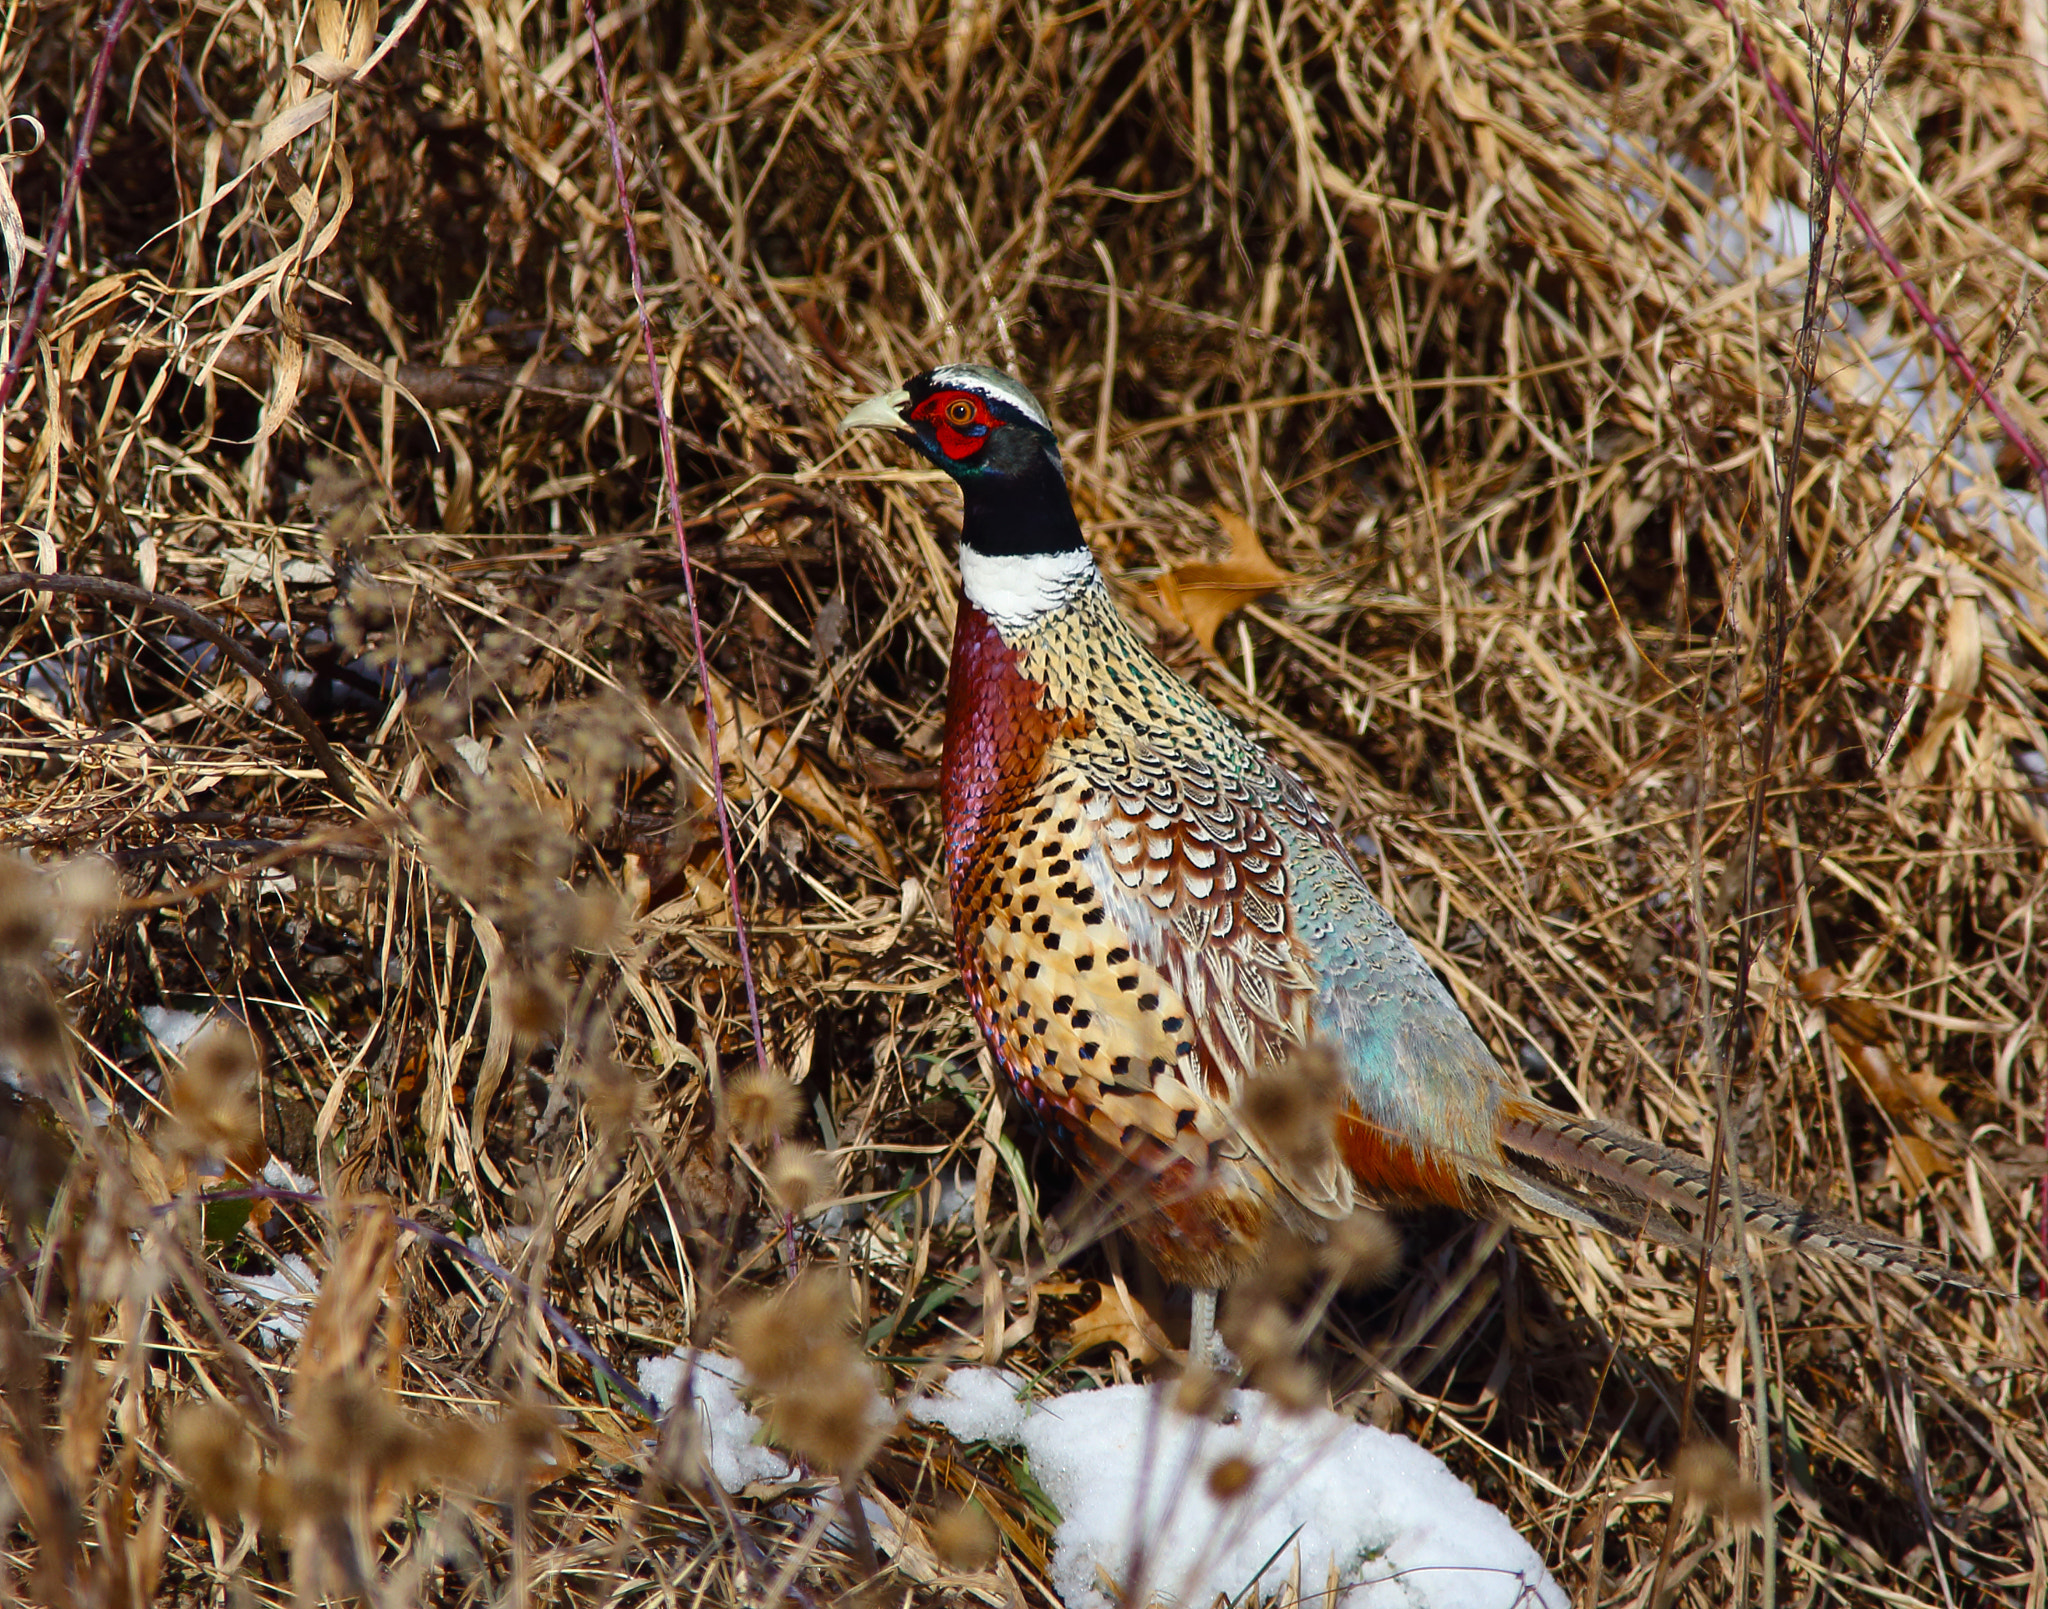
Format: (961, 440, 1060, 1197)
(0, 0, 2048, 1609)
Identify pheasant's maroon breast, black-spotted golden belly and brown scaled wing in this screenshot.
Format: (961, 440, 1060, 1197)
(944, 598, 1354, 1286)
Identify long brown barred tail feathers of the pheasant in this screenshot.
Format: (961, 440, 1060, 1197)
(1499, 1101, 1995, 1290)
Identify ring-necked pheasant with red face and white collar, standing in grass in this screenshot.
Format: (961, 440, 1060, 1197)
(842, 364, 1976, 1345)
